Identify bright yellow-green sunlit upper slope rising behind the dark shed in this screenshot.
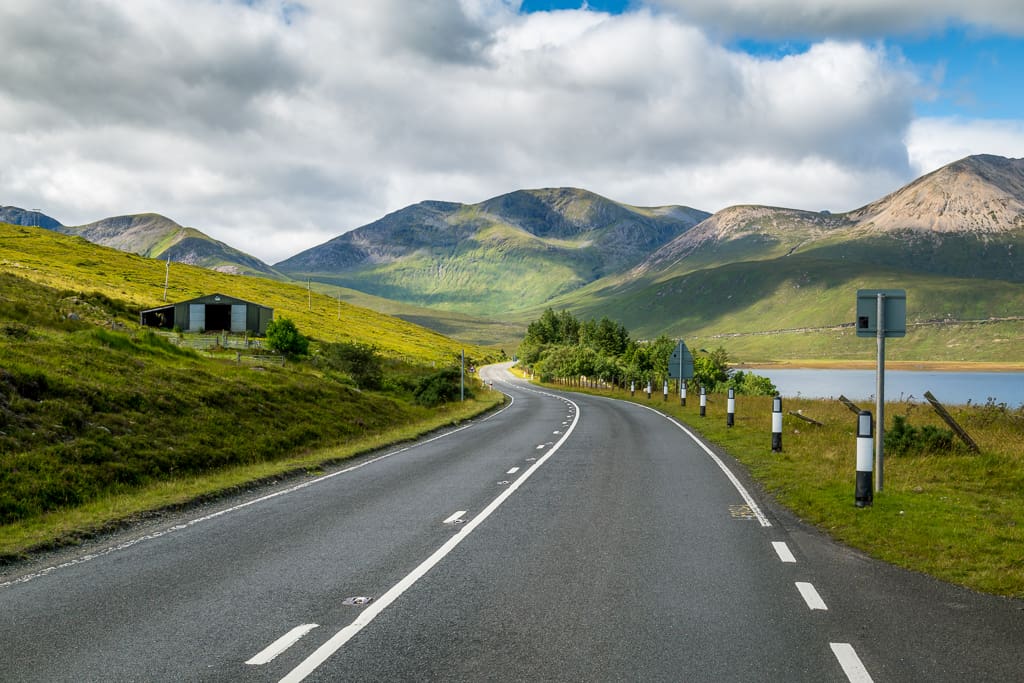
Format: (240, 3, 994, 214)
(0, 223, 489, 362)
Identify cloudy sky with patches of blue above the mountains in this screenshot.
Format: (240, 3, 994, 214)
(0, 0, 1024, 263)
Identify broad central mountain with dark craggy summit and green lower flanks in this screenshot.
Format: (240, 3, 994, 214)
(274, 187, 710, 315)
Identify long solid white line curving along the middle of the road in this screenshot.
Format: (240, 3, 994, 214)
(281, 391, 580, 683)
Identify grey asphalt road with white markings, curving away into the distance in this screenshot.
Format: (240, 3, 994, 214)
(0, 368, 1024, 681)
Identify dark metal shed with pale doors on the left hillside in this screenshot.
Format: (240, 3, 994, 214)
(139, 294, 273, 336)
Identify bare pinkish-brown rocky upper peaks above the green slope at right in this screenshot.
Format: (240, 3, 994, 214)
(628, 155, 1024, 282)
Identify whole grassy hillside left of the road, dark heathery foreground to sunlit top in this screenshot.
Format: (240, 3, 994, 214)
(0, 224, 502, 562)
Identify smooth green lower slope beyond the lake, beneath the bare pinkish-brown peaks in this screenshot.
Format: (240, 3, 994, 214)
(526, 255, 1024, 362)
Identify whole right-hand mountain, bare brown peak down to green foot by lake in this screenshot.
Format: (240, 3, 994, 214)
(516, 156, 1024, 359)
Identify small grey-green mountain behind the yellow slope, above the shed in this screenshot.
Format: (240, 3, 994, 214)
(51, 213, 285, 280)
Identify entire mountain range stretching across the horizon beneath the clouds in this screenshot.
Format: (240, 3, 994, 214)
(8, 155, 1024, 352)
